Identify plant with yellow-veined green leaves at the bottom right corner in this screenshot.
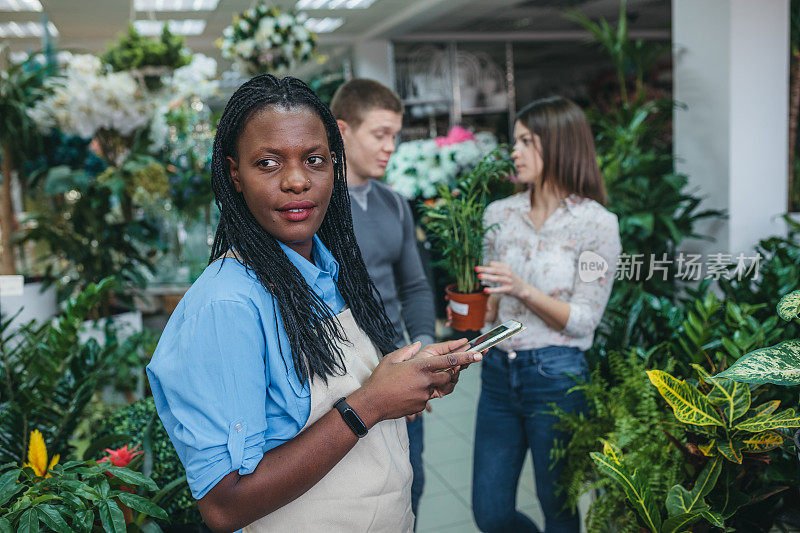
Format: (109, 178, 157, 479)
(591, 365, 800, 533)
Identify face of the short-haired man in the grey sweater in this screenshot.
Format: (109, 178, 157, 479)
(338, 109, 403, 180)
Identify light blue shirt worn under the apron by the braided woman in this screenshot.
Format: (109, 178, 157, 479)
(147, 235, 345, 499)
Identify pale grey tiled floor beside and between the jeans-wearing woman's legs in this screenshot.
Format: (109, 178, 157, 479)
(417, 365, 585, 533)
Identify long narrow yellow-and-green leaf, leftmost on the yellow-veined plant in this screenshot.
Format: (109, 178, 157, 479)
(589, 442, 661, 533)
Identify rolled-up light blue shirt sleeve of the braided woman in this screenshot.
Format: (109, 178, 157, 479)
(147, 301, 269, 499)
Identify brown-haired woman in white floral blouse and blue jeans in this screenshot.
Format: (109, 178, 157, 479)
(472, 97, 620, 533)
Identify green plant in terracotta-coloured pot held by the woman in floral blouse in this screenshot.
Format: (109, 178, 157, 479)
(423, 148, 514, 331)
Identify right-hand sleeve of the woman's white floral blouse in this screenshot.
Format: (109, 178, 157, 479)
(562, 211, 622, 337)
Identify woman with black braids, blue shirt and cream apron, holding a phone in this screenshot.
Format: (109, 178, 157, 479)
(147, 75, 481, 532)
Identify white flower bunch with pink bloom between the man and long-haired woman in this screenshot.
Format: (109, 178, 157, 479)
(385, 126, 497, 199)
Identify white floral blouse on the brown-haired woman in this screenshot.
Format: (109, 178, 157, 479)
(483, 191, 621, 351)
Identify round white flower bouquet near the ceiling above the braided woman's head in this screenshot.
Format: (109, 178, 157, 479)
(217, 4, 319, 76)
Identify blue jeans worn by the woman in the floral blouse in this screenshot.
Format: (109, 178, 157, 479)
(472, 346, 588, 533)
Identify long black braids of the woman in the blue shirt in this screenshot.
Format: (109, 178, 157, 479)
(209, 74, 394, 384)
